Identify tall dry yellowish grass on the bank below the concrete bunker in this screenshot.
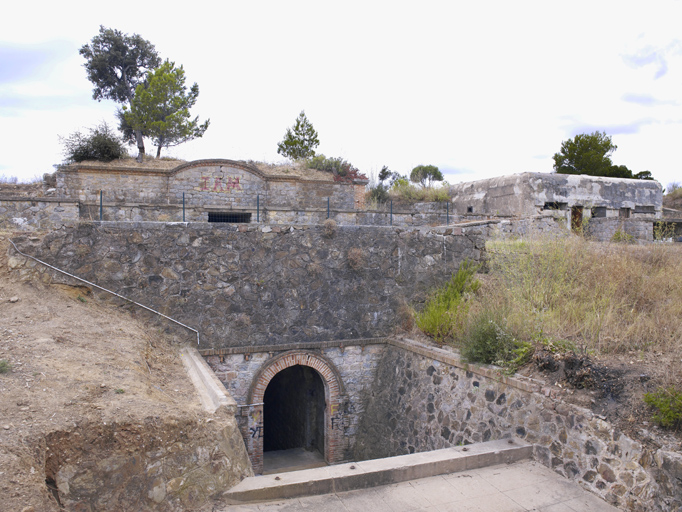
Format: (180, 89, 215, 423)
(477, 237, 682, 353)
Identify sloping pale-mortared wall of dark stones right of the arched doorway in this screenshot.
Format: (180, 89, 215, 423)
(356, 341, 682, 512)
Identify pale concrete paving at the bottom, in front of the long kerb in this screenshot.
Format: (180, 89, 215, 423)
(212, 460, 618, 512)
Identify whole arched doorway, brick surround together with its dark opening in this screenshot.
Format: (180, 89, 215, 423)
(242, 350, 345, 474)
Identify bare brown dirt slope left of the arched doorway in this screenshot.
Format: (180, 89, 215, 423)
(0, 232, 226, 511)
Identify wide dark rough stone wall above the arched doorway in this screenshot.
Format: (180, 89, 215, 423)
(11, 223, 485, 348)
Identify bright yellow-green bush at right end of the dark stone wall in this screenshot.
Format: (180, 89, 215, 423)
(416, 260, 480, 343)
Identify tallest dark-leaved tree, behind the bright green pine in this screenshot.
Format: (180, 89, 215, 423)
(79, 25, 161, 162)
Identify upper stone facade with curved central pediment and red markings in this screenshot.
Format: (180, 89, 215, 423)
(55, 160, 367, 218)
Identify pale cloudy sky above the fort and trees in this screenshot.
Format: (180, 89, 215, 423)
(0, 0, 682, 187)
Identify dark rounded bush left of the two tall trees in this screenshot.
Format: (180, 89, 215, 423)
(60, 123, 128, 163)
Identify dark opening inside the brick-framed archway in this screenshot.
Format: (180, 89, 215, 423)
(263, 365, 326, 456)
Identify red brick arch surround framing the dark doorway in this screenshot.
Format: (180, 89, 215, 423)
(242, 350, 345, 474)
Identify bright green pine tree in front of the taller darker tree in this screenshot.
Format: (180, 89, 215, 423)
(119, 60, 210, 158)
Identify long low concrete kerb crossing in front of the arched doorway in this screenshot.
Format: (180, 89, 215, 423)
(223, 438, 533, 505)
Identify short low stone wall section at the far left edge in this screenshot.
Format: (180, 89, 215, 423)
(0, 197, 78, 229)
